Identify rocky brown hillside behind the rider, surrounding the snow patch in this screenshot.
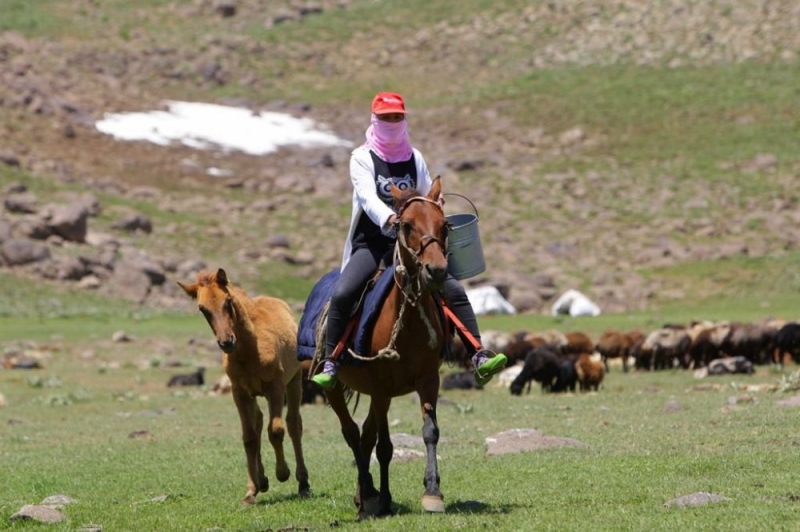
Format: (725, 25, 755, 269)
(0, 0, 800, 312)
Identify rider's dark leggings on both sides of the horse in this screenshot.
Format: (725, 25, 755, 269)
(325, 248, 481, 356)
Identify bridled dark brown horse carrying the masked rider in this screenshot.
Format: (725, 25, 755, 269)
(326, 177, 456, 518)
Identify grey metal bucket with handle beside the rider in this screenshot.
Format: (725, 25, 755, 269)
(444, 192, 486, 279)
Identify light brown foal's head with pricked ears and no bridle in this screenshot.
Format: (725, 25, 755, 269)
(178, 268, 241, 353)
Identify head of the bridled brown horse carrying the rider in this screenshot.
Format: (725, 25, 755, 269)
(392, 176, 448, 290)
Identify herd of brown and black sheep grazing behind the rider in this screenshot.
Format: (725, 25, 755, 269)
(444, 319, 800, 395)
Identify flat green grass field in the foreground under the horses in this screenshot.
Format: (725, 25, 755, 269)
(0, 328, 800, 531)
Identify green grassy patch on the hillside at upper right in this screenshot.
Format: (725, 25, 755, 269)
(484, 63, 800, 171)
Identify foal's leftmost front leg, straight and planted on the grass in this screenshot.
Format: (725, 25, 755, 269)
(232, 388, 269, 504)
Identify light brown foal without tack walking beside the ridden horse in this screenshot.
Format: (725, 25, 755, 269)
(178, 269, 310, 504)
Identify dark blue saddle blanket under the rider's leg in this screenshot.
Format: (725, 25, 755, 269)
(297, 268, 394, 362)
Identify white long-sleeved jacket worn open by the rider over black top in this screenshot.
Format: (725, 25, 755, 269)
(342, 145, 431, 269)
